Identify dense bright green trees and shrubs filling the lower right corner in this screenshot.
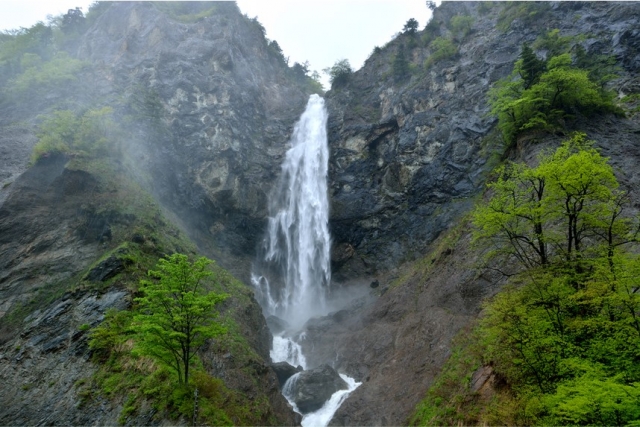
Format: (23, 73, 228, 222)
(413, 134, 640, 425)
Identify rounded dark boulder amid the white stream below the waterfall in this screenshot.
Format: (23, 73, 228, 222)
(283, 365, 349, 414)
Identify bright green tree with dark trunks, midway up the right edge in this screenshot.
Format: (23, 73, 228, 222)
(473, 133, 631, 268)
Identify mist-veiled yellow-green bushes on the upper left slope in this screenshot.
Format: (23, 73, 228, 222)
(31, 107, 114, 163)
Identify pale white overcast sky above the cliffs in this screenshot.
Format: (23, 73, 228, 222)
(0, 0, 431, 87)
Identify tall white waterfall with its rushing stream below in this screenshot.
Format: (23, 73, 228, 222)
(251, 95, 360, 427)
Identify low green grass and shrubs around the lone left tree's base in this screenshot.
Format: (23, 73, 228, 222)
(86, 254, 275, 425)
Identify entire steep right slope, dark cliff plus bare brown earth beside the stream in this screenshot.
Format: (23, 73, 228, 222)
(306, 2, 640, 425)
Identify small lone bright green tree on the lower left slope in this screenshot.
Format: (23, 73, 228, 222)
(133, 254, 227, 384)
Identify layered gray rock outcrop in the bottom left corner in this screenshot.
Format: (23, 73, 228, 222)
(0, 289, 130, 425)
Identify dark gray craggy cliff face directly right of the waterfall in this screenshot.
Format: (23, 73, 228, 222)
(327, 2, 639, 281)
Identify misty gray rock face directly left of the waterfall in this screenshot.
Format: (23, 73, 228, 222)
(78, 2, 308, 282)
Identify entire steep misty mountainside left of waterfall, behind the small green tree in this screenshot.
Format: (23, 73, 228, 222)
(0, 2, 310, 425)
